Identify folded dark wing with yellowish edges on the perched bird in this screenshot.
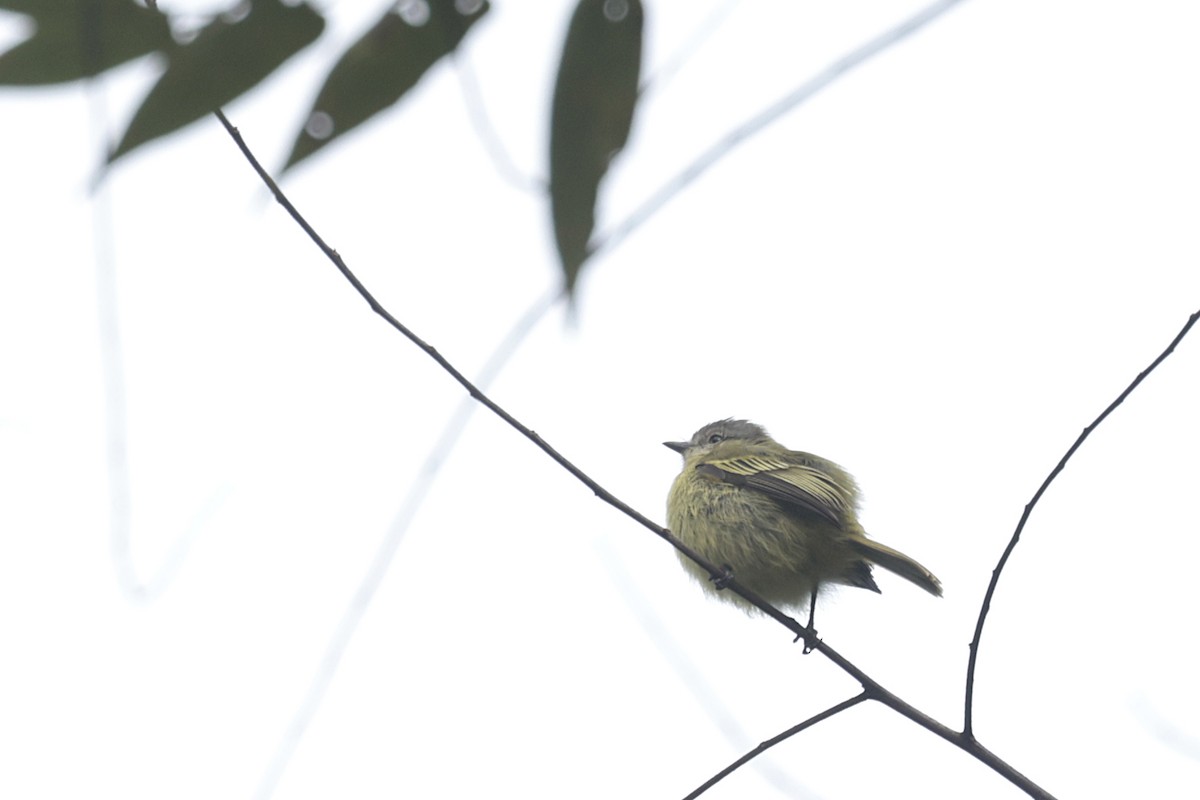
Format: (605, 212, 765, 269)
(696, 456, 850, 527)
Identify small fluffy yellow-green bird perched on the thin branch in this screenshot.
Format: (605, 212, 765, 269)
(662, 420, 942, 628)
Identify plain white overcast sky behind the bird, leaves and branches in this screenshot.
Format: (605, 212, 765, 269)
(0, 0, 1200, 800)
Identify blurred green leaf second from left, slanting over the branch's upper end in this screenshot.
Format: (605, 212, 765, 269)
(108, 0, 325, 163)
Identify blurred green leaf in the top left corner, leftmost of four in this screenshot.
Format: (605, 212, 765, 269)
(0, 0, 174, 86)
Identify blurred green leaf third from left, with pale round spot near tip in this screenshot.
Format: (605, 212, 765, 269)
(283, 0, 491, 170)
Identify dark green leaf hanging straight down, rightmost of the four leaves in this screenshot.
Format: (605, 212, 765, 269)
(550, 0, 642, 295)
